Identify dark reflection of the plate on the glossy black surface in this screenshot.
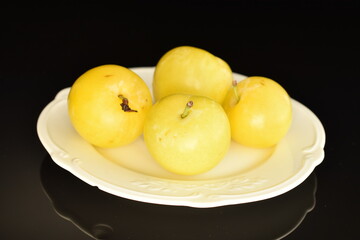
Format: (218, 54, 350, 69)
(40, 156, 317, 240)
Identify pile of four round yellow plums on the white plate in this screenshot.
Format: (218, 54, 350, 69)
(68, 46, 292, 175)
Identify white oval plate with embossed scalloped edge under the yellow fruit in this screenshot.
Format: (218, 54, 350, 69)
(37, 67, 325, 207)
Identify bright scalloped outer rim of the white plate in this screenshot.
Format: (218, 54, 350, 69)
(37, 67, 325, 208)
